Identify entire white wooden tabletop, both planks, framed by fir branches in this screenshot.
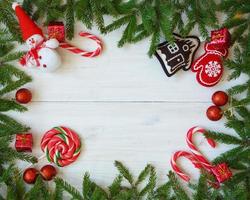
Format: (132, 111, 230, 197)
(8, 21, 245, 194)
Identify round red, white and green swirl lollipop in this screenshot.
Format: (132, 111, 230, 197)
(41, 126, 81, 167)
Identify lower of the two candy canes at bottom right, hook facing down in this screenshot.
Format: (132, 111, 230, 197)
(171, 151, 202, 182)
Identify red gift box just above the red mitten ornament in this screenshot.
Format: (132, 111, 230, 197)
(210, 28, 230, 49)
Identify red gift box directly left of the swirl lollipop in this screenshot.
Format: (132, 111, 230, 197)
(15, 133, 33, 152)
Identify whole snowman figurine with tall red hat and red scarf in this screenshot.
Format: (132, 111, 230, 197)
(12, 3, 61, 72)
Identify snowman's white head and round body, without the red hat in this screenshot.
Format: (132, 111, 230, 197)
(25, 34, 61, 72)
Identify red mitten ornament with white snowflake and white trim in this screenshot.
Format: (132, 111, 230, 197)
(192, 43, 228, 87)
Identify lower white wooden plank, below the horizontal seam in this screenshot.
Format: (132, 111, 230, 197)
(10, 102, 233, 190)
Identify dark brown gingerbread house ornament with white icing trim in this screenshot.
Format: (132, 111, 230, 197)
(155, 34, 200, 77)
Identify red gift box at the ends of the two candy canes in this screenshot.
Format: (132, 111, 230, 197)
(212, 163, 233, 183)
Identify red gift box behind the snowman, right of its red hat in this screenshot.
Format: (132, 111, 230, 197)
(48, 22, 65, 42)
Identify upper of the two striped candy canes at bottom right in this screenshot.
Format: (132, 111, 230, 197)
(186, 126, 216, 171)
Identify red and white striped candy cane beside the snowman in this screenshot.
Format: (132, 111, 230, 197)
(60, 32, 103, 57)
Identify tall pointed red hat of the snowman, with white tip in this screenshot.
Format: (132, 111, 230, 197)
(12, 3, 44, 41)
